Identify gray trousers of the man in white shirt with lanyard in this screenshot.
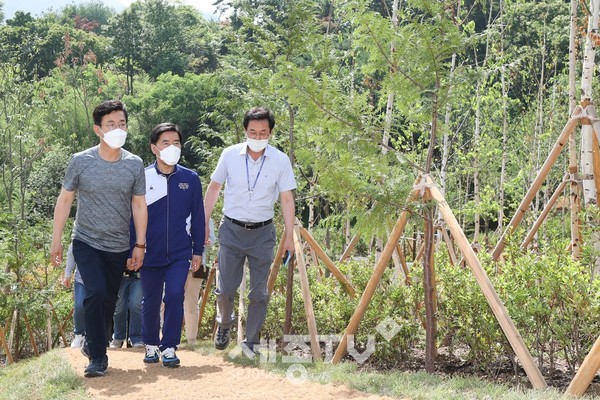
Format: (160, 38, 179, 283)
(215, 218, 276, 343)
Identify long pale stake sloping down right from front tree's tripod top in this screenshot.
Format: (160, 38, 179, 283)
(427, 177, 547, 389)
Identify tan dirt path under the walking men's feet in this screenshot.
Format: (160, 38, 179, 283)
(65, 348, 398, 400)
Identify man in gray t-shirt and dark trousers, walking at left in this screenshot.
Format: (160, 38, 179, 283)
(50, 100, 148, 377)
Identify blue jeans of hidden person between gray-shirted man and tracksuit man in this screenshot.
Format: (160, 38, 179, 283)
(113, 275, 142, 344)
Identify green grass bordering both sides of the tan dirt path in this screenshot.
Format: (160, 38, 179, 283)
(0, 342, 591, 400)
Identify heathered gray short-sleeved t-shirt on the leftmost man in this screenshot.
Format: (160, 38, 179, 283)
(63, 146, 146, 253)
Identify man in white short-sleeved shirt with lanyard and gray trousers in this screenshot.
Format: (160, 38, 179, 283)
(204, 107, 296, 352)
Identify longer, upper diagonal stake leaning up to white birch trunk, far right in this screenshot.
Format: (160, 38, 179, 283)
(492, 111, 582, 261)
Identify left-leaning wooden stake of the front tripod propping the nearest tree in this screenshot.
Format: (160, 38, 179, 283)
(331, 183, 421, 364)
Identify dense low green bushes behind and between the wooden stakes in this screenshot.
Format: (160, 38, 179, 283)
(263, 238, 600, 373)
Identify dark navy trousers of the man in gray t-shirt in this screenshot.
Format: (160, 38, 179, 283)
(73, 240, 129, 358)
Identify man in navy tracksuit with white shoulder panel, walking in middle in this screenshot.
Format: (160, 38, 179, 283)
(132, 123, 205, 367)
